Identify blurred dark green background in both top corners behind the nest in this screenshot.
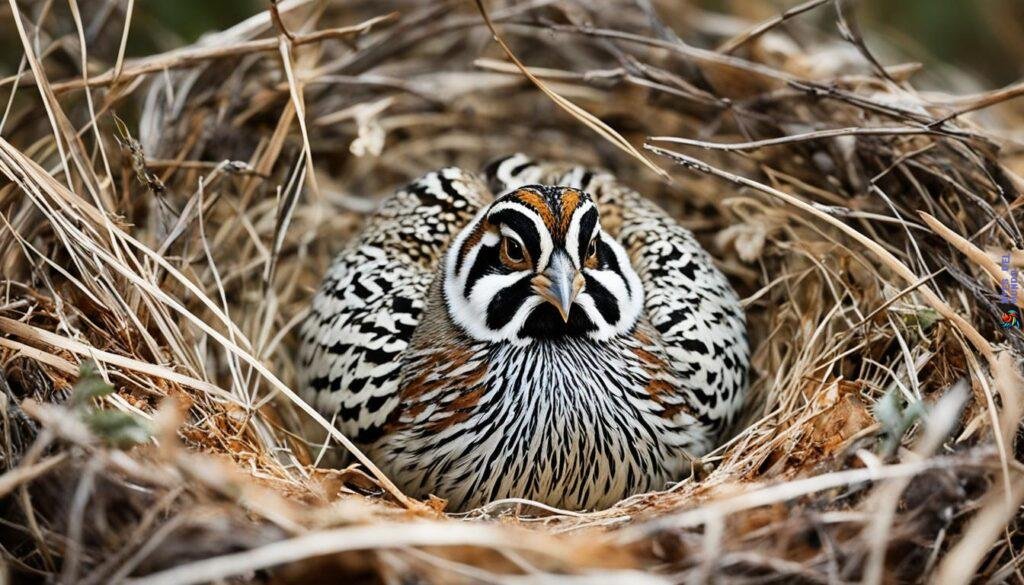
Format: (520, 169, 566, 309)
(0, 0, 1024, 87)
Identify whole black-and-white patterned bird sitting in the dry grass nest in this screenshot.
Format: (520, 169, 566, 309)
(300, 155, 748, 509)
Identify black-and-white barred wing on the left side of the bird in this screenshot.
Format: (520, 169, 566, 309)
(299, 168, 490, 445)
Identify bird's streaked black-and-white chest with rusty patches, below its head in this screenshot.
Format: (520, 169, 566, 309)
(369, 293, 710, 509)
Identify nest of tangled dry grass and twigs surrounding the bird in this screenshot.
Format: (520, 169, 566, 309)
(0, 1, 1024, 583)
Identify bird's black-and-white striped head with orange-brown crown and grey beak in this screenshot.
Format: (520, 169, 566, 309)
(444, 184, 643, 343)
